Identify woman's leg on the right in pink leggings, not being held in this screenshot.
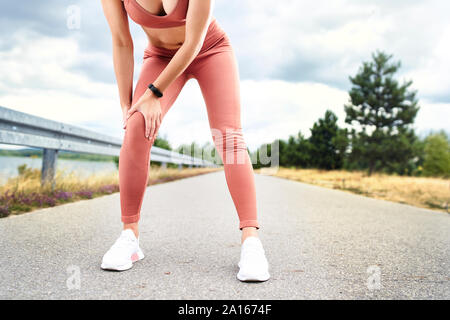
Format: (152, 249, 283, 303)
(190, 51, 259, 240)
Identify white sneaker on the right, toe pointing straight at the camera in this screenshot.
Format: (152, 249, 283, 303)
(237, 237, 270, 281)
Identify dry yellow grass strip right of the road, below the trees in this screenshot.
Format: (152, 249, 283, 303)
(256, 168, 450, 212)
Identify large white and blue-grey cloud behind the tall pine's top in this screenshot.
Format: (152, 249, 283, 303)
(216, 0, 450, 102)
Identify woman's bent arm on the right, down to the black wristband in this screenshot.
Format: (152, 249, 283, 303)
(153, 0, 213, 92)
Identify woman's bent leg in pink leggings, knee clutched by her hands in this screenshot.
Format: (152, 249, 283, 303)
(119, 55, 187, 236)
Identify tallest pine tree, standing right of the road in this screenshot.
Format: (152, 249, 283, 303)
(344, 52, 419, 175)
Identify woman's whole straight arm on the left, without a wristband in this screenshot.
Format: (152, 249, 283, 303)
(102, 0, 134, 128)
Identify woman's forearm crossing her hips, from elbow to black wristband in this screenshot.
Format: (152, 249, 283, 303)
(153, 43, 201, 92)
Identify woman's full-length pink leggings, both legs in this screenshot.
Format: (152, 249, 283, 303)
(119, 27, 259, 229)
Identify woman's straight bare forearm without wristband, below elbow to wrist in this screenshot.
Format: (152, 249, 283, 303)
(113, 44, 134, 108)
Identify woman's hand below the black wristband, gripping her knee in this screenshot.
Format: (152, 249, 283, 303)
(127, 89, 162, 140)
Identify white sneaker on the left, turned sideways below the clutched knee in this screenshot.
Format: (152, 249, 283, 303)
(101, 229, 144, 271)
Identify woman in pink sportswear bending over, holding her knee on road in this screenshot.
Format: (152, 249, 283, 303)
(101, 0, 270, 281)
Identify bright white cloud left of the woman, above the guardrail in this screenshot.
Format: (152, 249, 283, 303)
(0, 31, 112, 97)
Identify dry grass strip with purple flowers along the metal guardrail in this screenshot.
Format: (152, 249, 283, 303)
(0, 165, 220, 218)
